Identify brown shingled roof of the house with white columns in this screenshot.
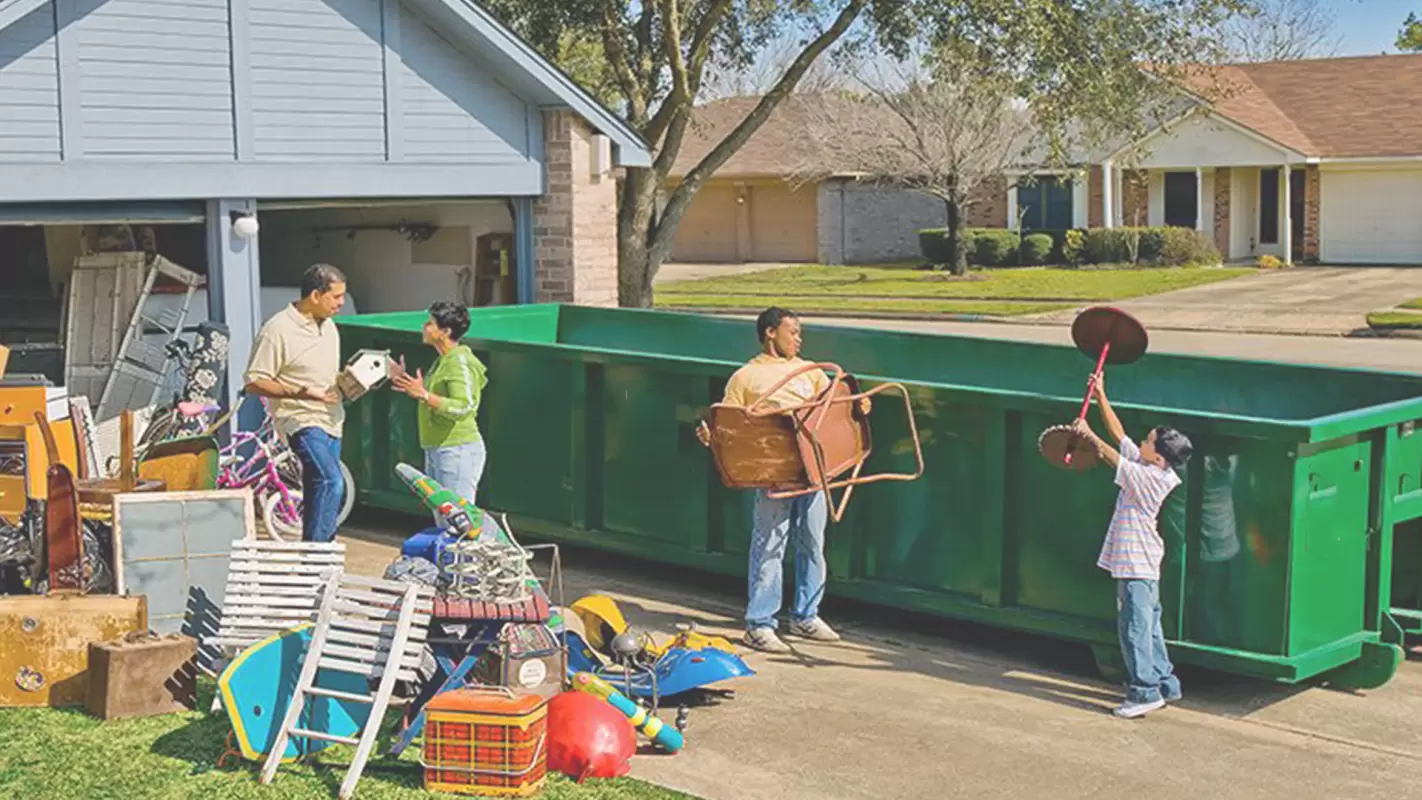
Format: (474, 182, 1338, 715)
(1188, 55, 1422, 158)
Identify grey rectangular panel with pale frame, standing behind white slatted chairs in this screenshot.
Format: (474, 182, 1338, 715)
(114, 489, 256, 639)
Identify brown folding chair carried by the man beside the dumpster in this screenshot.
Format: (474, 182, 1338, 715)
(705, 362, 923, 523)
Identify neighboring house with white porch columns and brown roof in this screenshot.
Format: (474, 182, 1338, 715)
(1008, 55, 1422, 264)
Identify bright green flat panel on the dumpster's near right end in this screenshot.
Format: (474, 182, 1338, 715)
(1288, 438, 1372, 655)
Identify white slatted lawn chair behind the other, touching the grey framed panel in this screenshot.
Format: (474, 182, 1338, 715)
(203, 539, 346, 712)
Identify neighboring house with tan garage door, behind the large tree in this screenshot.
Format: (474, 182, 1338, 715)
(668, 95, 1007, 264)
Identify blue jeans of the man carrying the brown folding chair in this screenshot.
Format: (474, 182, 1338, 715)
(745, 492, 828, 628)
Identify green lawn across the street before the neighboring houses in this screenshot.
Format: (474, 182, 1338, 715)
(656, 264, 1256, 315)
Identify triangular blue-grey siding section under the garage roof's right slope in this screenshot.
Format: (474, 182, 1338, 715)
(400, 9, 530, 162)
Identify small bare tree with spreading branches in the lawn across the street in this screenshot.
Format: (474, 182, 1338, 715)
(792, 51, 1041, 274)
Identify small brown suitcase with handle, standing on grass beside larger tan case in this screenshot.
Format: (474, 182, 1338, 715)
(85, 631, 198, 719)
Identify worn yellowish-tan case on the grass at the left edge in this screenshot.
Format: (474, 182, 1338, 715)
(0, 594, 148, 708)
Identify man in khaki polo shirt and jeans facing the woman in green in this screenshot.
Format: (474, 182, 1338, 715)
(243, 264, 346, 541)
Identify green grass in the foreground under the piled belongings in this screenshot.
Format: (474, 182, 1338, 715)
(0, 681, 687, 800)
